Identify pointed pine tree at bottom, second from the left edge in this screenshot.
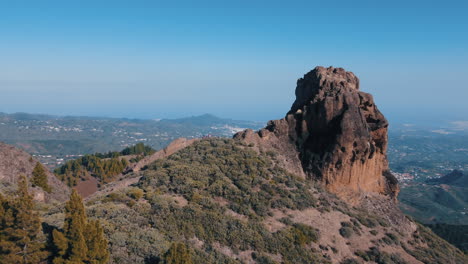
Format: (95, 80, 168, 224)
(52, 190, 109, 264)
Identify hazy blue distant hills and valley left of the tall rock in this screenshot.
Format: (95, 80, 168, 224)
(0, 113, 264, 168)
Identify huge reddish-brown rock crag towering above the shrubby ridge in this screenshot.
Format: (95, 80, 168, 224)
(234, 67, 399, 200)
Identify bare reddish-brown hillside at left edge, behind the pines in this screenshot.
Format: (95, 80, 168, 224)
(0, 142, 70, 202)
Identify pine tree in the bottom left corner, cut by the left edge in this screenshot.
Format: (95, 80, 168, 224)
(0, 176, 48, 264)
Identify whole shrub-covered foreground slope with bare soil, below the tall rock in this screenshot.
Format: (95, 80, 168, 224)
(45, 139, 466, 263)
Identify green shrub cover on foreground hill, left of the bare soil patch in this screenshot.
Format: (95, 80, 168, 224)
(77, 139, 327, 263)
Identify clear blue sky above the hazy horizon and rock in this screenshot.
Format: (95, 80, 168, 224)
(0, 0, 468, 120)
